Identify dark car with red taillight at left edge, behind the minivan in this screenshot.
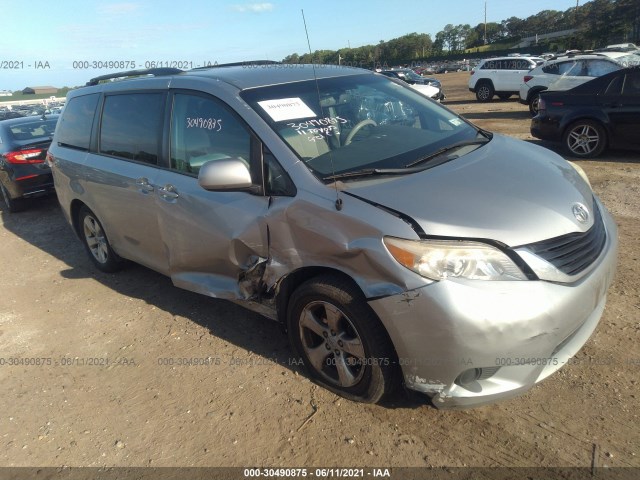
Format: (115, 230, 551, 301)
(0, 115, 59, 212)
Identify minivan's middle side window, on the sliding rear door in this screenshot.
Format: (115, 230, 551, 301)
(100, 93, 165, 165)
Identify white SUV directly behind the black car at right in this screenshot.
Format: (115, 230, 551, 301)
(519, 52, 640, 115)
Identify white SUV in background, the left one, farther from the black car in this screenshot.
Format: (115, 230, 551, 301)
(469, 56, 544, 102)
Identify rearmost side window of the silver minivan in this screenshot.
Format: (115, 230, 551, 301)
(58, 93, 100, 150)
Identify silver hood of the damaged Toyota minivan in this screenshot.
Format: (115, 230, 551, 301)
(345, 134, 594, 247)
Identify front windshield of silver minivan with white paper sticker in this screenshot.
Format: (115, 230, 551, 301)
(241, 74, 478, 182)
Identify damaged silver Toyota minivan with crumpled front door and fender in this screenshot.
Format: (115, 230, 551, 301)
(48, 64, 617, 408)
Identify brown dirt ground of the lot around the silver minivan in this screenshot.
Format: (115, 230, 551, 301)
(0, 73, 640, 467)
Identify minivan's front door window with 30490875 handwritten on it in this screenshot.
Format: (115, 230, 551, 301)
(171, 93, 251, 176)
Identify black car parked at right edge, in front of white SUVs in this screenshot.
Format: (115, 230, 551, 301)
(531, 66, 640, 158)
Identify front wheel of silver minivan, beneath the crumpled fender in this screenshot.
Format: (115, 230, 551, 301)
(287, 275, 399, 403)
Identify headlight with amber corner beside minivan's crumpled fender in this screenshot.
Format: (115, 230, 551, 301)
(383, 237, 527, 280)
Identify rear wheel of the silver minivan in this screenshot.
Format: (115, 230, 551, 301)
(78, 207, 123, 273)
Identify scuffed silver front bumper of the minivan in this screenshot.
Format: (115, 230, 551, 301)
(369, 203, 617, 408)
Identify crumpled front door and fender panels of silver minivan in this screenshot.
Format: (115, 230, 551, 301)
(156, 165, 429, 317)
